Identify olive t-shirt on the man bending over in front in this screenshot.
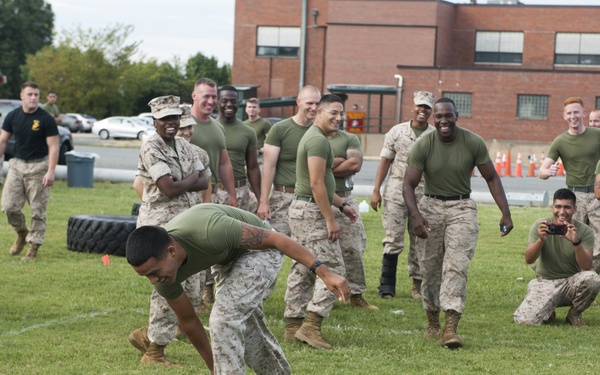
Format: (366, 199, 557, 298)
(154, 203, 270, 299)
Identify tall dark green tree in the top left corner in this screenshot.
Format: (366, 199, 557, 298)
(0, 0, 54, 98)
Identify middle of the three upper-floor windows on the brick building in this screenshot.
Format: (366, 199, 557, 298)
(475, 31, 523, 64)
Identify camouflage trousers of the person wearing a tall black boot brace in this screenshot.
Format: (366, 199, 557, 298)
(381, 200, 421, 280)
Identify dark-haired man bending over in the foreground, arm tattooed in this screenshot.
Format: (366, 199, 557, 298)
(126, 204, 350, 374)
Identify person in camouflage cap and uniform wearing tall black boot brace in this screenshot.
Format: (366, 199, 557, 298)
(371, 91, 435, 299)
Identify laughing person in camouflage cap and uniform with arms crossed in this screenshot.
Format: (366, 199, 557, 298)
(128, 95, 208, 365)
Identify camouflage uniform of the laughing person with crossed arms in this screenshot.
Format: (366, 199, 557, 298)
(137, 133, 205, 346)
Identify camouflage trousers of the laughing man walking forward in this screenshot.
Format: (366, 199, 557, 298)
(416, 196, 479, 314)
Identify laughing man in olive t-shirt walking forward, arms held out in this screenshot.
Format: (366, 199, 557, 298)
(403, 98, 513, 348)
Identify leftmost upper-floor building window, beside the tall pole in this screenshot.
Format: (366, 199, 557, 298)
(256, 26, 300, 57)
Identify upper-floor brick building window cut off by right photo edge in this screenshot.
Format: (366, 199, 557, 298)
(554, 33, 600, 65)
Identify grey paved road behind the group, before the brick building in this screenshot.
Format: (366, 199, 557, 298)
(74, 133, 565, 196)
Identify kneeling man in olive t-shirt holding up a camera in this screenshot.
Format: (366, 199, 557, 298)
(514, 189, 600, 327)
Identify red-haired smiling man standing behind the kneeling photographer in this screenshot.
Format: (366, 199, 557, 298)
(539, 97, 600, 272)
